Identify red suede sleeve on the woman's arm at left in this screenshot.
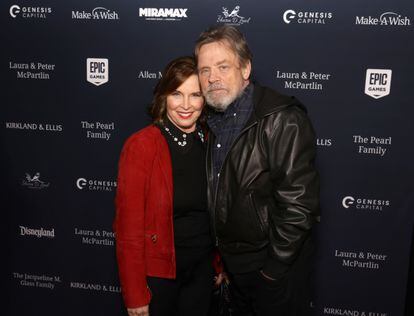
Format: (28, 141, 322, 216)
(113, 136, 151, 308)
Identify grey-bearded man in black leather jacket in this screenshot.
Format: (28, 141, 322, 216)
(195, 25, 319, 316)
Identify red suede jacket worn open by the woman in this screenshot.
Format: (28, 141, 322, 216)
(114, 125, 176, 308)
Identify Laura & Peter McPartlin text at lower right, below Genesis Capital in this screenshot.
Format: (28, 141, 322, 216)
(334, 249, 388, 270)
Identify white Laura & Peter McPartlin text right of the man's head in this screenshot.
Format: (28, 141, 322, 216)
(276, 70, 332, 90)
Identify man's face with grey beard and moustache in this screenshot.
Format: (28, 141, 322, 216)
(197, 42, 251, 111)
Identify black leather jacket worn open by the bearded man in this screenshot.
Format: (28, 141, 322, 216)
(207, 85, 319, 276)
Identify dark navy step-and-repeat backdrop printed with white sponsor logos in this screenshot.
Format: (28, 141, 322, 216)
(4, 0, 414, 316)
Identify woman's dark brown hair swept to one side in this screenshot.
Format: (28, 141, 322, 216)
(149, 56, 202, 125)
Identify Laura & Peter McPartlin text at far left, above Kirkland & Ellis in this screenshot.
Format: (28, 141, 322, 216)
(9, 61, 55, 80)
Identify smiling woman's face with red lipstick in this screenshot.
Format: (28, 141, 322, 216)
(167, 75, 204, 133)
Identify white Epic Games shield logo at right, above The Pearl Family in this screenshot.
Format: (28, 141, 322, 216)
(365, 69, 392, 99)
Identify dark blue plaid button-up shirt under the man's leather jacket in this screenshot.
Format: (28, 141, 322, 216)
(207, 84, 253, 193)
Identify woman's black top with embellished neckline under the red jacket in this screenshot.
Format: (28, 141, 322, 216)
(159, 120, 212, 271)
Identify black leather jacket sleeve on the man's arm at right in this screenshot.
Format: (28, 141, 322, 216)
(263, 108, 319, 278)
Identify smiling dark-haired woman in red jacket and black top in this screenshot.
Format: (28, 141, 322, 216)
(114, 57, 214, 316)
